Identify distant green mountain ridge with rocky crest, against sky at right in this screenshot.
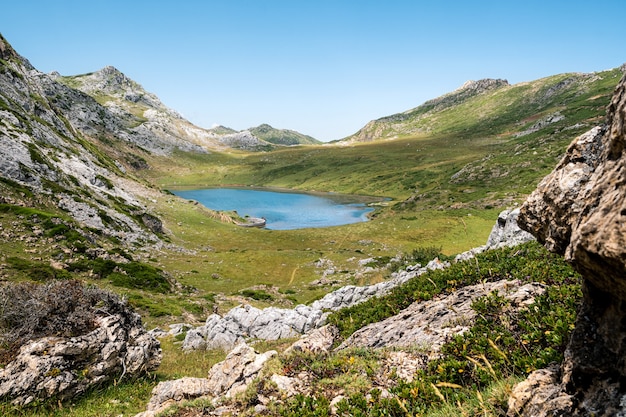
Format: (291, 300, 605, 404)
(340, 70, 617, 143)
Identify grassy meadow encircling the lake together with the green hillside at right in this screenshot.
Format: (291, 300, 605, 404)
(122, 70, 621, 320)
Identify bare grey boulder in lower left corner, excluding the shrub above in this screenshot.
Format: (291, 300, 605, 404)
(0, 313, 161, 405)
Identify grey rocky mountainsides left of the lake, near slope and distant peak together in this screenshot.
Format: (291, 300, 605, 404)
(0, 36, 316, 247)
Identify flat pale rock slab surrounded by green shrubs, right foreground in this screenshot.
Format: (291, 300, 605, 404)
(339, 280, 544, 355)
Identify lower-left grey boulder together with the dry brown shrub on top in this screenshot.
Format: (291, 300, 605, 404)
(0, 283, 161, 405)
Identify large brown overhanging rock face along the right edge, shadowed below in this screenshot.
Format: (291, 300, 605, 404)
(509, 73, 626, 416)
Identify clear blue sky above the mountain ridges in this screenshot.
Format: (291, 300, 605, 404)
(0, 0, 626, 141)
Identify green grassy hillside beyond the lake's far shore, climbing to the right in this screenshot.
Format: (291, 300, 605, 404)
(146, 70, 621, 209)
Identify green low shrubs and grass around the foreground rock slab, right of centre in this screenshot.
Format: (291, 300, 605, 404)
(235, 243, 581, 416)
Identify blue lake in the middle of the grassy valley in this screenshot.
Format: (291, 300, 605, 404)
(172, 188, 374, 230)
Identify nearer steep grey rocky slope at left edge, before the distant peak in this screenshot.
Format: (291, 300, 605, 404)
(0, 37, 161, 247)
